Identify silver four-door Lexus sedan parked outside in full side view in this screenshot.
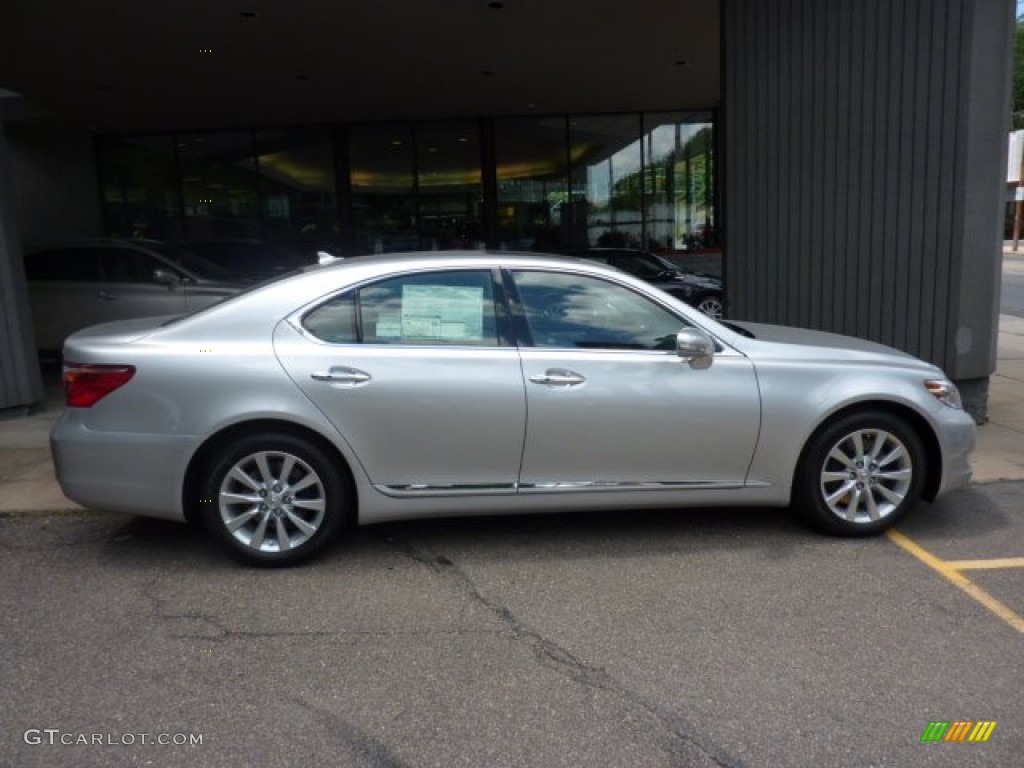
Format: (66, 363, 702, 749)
(51, 252, 975, 564)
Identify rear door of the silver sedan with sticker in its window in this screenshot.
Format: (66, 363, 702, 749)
(274, 269, 526, 497)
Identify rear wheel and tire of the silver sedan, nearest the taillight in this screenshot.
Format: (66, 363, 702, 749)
(199, 433, 353, 566)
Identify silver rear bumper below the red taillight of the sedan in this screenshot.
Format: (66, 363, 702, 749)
(50, 409, 197, 521)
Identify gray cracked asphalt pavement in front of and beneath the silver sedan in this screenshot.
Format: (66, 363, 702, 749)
(0, 481, 1024, 768)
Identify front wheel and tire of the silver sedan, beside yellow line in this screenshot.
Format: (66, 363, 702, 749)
(793, 411, 928, 537)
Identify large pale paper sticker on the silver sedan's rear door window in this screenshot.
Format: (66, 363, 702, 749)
(399, 286, 483, 341)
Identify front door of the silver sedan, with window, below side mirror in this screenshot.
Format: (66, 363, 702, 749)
(511, 269, 761, 493)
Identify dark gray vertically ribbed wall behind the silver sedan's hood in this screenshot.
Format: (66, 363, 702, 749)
(722, 0, 1015, 416)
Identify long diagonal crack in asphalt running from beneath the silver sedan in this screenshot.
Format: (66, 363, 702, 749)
(382, 535, 743, 768)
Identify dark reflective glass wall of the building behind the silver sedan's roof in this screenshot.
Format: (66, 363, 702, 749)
(97, 112, 718, 260)
